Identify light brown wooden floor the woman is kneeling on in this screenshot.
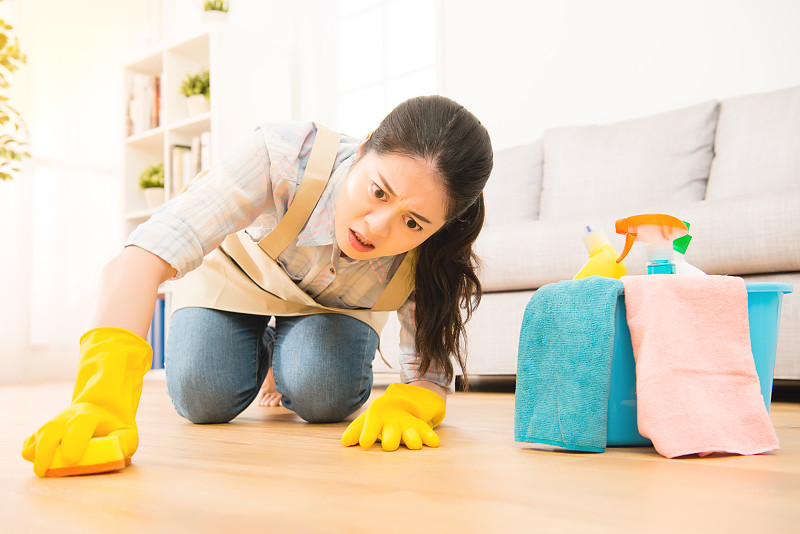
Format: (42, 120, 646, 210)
(0, 378, 800, 534)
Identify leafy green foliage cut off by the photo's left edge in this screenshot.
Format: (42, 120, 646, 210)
(0, 0, 31, 180)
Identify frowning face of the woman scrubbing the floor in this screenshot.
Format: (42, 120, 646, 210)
(335, 152, 447, 260)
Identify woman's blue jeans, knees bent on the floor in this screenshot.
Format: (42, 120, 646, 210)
(164, 308, 378, 423)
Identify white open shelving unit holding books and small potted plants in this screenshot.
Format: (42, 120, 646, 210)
(123, 23, 292, 237)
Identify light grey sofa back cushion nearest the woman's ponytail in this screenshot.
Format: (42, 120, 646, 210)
(483, 139, 542, 226)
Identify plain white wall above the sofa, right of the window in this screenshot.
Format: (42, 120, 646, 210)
(442, 0, 800, 148)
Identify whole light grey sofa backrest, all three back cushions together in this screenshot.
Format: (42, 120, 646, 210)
(484, 83, 800, 226)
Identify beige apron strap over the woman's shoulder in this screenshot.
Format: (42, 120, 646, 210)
(258, 124, 339, 259)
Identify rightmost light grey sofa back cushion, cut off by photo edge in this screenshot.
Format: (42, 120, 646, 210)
(706, 87, 800, 199)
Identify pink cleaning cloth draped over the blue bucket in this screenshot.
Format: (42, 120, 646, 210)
(622, 274, 778, 458)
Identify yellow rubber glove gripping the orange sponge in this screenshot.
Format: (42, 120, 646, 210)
(22, 327, 153, 477)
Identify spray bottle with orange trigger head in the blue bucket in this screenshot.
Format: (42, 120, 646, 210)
(615, 213, 689, 274)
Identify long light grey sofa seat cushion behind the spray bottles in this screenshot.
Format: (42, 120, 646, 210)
(475, 191, 800, 292)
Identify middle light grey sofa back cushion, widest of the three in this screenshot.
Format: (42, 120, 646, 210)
(539, 101, 719, 219)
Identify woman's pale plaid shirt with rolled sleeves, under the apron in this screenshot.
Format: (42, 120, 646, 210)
(125, 122, 449, 388)
